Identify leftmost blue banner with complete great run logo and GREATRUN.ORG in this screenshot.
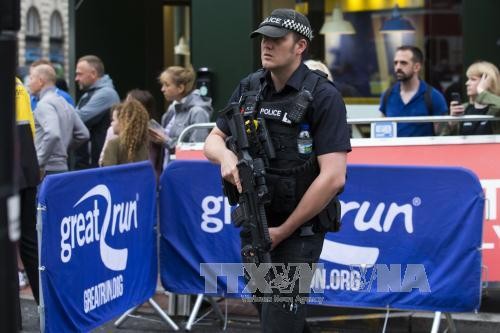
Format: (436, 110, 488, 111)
(38, 162, 157, 333)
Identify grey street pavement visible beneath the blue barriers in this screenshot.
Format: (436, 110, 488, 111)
(17, 289, 500, 333)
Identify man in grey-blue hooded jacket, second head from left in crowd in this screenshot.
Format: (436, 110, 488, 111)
(75, 55, 120, 169)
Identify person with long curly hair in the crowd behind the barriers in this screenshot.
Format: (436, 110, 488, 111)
(102, 99, 149, 166)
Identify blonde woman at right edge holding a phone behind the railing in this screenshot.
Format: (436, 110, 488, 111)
(449, 61, 500, 135)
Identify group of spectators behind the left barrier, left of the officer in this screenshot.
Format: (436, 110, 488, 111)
(16, 55, 213, 322)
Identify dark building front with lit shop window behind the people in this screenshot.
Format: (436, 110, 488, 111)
(61, 0, 500, 113)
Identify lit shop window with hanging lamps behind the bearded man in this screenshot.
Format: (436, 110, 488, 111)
(324, 0, 463, 103)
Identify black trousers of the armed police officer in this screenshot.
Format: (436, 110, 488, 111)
(242, 232, 325, 333)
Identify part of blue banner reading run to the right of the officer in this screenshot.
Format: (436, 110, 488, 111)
(313, 166, 484, 312)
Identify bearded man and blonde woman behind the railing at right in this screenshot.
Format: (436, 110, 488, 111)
(380, 45, 500, 137)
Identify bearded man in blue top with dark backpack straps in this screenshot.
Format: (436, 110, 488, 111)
(380, 45, 448, 137)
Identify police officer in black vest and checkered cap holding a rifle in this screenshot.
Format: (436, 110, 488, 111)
(204, 9, 351, 332)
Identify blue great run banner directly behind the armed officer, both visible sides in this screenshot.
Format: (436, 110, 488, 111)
(160, 161, 484, 312)
